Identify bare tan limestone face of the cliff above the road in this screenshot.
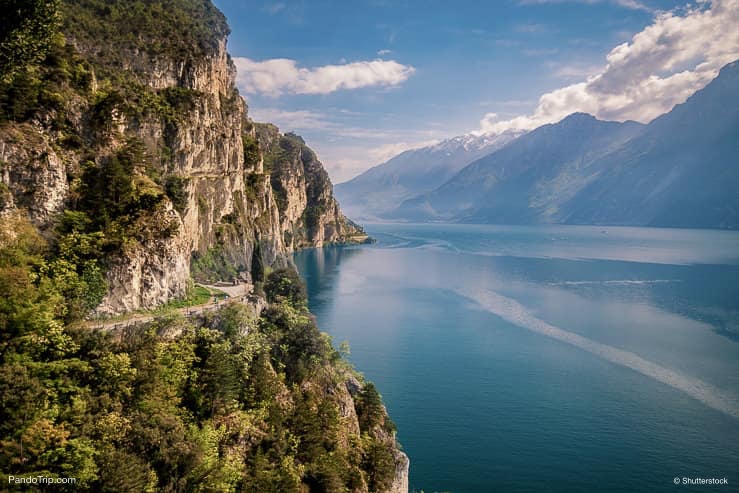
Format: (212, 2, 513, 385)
(0, 25, 363, 314)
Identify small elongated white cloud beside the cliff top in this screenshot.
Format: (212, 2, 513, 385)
(234, 57, 415, 97)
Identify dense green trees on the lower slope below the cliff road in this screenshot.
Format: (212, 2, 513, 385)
(0, 229, 402, 493)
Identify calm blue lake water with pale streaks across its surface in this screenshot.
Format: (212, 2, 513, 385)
(295, 224, 739, 493)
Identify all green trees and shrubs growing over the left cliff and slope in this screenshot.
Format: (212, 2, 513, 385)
(0, 0, 402, 493)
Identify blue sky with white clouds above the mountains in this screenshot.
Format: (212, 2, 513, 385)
(215, 0, 739, 183)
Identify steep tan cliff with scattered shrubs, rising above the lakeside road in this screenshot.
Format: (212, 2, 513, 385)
(0, 0, 363, 314)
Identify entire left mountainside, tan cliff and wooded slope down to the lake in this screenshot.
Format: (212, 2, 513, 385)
(0, 0, 408, 493)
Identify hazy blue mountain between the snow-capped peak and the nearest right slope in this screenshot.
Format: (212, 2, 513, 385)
(391, 113, 643, 223)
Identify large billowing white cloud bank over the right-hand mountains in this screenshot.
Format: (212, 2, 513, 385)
(480, 0, 739, 133)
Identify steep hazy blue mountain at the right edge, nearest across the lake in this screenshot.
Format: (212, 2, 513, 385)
(558, 61, 739, 229)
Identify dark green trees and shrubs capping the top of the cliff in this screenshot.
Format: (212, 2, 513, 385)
(0, 0, 208, 134)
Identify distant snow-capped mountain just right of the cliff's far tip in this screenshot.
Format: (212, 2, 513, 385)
(334, 131, 524, 219)
